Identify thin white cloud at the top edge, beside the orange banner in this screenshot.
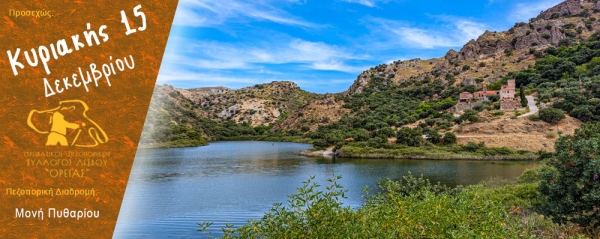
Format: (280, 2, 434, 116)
(173, 0, 319, 28)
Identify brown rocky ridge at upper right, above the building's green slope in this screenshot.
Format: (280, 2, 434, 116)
(345, 0, 600, 95)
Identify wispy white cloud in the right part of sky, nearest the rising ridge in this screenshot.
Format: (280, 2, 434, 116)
(369, 16, 486, 49)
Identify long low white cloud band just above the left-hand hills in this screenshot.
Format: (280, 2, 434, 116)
(164, 38, 368, 73)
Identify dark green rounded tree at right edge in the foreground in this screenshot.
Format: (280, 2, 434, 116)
(538, 123, 600, 228)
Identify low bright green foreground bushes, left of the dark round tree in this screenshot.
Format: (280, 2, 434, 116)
(198, 173, 581, 238)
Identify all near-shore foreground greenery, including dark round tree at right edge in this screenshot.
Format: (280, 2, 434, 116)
(198, 123, 600, 238)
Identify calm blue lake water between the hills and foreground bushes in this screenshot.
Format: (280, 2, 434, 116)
(114, 142, 538, 238)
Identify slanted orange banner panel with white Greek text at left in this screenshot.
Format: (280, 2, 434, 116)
(0, 0, 177, 238)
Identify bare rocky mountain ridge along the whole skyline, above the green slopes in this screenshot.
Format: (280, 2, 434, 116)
(144, 0, 600, 150)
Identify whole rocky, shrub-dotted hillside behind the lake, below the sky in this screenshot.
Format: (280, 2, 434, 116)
(142, 0, 600, 153)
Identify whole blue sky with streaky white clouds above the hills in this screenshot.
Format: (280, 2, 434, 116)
(157, 0, 561, 93)
